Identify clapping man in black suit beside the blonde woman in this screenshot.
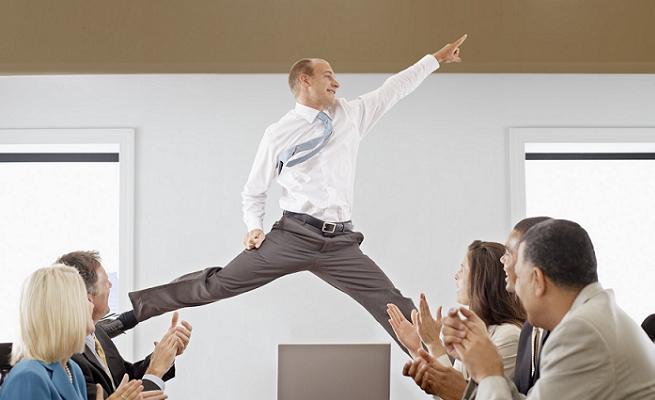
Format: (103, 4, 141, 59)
(57, 251, 192, 400)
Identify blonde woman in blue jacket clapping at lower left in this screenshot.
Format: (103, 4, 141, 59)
(0, 265, 148, 400)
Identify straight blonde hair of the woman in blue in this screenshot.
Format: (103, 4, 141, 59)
(12, 264, 91, 364)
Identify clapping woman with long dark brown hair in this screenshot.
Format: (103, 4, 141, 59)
(387, 240, 526, 398)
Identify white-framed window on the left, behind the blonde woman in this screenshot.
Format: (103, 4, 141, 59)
(0, 129, 133, 351)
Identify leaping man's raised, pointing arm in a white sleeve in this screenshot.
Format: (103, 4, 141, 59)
(346, 35, 466, 137)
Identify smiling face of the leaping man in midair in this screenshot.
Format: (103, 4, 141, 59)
(297, 58, 340, 110)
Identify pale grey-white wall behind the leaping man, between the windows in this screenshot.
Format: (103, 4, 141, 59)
(0, 70, 655, 399)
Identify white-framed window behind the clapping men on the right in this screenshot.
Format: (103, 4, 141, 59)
(510, 128, 655, 323)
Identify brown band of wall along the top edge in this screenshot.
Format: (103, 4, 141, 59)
(0, 0, 655, 74)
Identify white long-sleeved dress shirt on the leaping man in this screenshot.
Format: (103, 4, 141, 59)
(242, 55, 439, 231)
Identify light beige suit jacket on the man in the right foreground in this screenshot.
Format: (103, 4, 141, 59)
(476, 283, 655, 400)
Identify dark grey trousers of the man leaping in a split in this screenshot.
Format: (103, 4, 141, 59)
(129, 216, 415, 350)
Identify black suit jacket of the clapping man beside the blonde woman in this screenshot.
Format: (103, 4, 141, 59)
(72, 325, 175, 400)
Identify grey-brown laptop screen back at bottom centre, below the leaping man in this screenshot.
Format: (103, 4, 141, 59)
(277, 343, 391, 400)
